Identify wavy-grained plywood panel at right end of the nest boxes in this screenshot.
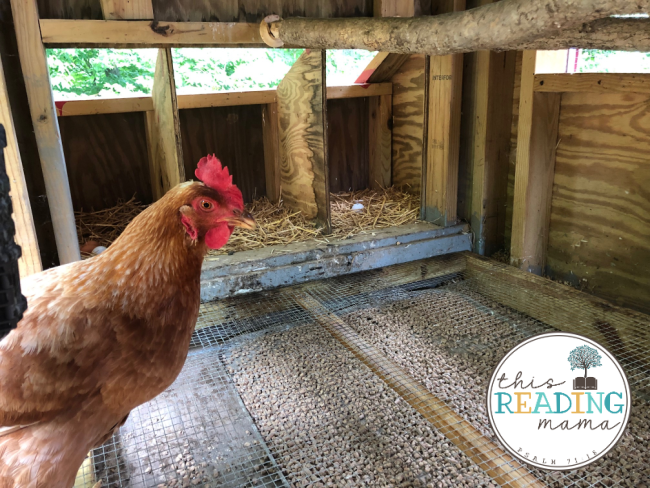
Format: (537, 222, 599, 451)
(391, 54, 426, 193)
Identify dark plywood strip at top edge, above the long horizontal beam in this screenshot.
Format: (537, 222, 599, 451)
(147, 0, 372, 23)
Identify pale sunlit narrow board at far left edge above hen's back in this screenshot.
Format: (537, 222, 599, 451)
(0, 56, 43, 278)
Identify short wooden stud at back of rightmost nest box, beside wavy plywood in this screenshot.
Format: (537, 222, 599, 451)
(368, 95, 393, 189)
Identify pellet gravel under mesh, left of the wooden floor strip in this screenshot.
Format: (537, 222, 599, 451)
(224, 325, 496, 487)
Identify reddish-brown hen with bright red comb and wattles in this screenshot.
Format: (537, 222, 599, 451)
(0, 156, 255, 488)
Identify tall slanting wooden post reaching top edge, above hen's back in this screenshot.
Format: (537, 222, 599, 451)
(11, 0, 81, 264)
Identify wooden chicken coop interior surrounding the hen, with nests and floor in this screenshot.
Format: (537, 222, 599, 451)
(0, 0, 650, 488)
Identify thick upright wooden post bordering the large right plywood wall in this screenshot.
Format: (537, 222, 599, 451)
(510, 51, 560, 274)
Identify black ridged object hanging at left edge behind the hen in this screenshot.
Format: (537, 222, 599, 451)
(0, 124, 27, 340)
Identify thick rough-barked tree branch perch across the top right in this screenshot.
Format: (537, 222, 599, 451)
(261, 0, 650, 56)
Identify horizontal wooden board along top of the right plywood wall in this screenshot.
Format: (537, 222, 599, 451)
(534, 73, 650, 95)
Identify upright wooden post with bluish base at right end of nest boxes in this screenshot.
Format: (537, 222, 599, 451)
(422, 0, 465, 227)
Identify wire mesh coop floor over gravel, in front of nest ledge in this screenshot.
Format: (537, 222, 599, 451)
(75, 256, 650, 488)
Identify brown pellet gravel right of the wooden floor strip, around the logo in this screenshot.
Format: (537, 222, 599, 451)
(341, 290, 650, 487)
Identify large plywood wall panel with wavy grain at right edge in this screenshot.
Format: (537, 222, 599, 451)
(547, 93, 650, 313)
